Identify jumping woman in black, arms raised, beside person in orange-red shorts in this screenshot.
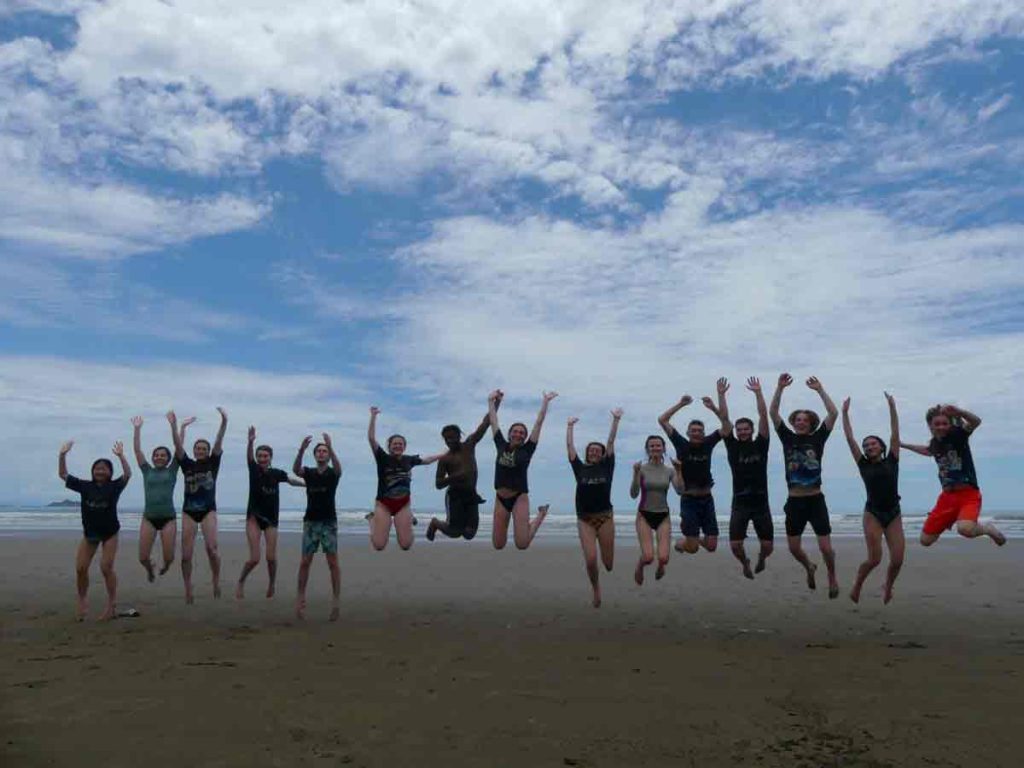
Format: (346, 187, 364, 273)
(843, 392, 906, 604)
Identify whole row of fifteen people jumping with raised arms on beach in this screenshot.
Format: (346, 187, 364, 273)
(58, 374, 1006, 621)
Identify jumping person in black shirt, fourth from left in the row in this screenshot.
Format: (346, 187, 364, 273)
(234, 427, 306, 600)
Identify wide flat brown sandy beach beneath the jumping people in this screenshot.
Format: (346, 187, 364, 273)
(0, 525, 1024, 767)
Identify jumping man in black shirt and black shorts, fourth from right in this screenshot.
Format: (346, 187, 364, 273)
(719, 376, 775, 579)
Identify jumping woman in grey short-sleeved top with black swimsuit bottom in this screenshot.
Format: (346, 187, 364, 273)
(630, 434, 683, 585)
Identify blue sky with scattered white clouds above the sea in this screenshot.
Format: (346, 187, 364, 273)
(0, 0, 1024, 516)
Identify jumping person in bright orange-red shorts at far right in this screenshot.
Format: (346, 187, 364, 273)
(900, 406, 1007, 547)
